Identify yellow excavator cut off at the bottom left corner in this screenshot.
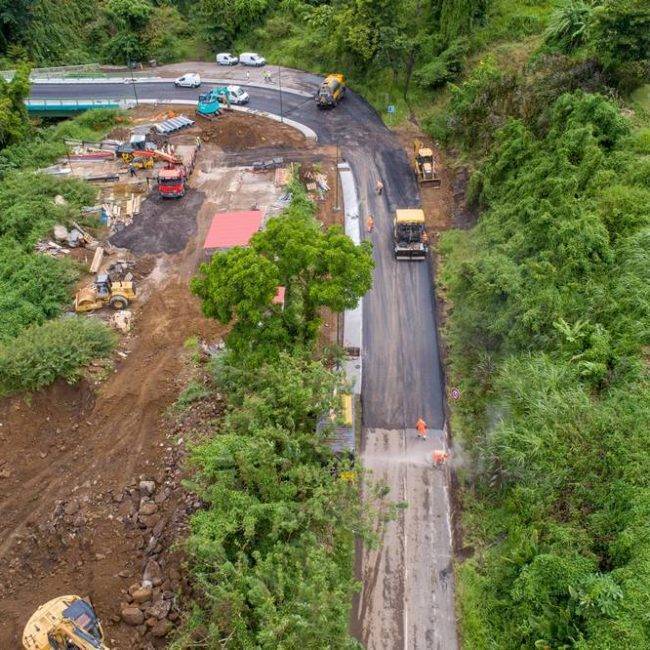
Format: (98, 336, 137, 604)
(23, 596, 109, 650)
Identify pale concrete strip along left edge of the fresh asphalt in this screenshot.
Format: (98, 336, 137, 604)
(338, 163, 363, 395)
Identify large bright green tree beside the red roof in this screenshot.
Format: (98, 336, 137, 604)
(192, 184, 373, 352)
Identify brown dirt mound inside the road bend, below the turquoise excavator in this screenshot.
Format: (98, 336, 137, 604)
(199, 113, 306, 151)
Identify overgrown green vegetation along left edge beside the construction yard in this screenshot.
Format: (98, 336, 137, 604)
(0, 94, 121, 393)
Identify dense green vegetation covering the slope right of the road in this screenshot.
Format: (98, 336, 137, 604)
(428, 2, 650, 650)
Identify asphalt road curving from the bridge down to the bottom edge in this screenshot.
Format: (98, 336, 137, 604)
(31, 75, 458, 650)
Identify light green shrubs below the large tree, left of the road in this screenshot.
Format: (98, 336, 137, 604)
(175, 353, 369, 648)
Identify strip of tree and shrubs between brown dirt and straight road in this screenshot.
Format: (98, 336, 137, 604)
(177, 176, 372, 649)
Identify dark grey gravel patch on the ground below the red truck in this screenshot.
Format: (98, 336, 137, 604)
(110, 189, 205, 254)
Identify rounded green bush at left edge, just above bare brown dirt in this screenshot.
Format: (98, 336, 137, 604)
(0, 317, 116, 394)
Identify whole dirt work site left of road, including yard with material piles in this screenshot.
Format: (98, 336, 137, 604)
(0, 107, 342, 648)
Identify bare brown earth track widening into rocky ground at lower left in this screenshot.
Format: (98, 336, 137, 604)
(0, 110, 338, 649)
